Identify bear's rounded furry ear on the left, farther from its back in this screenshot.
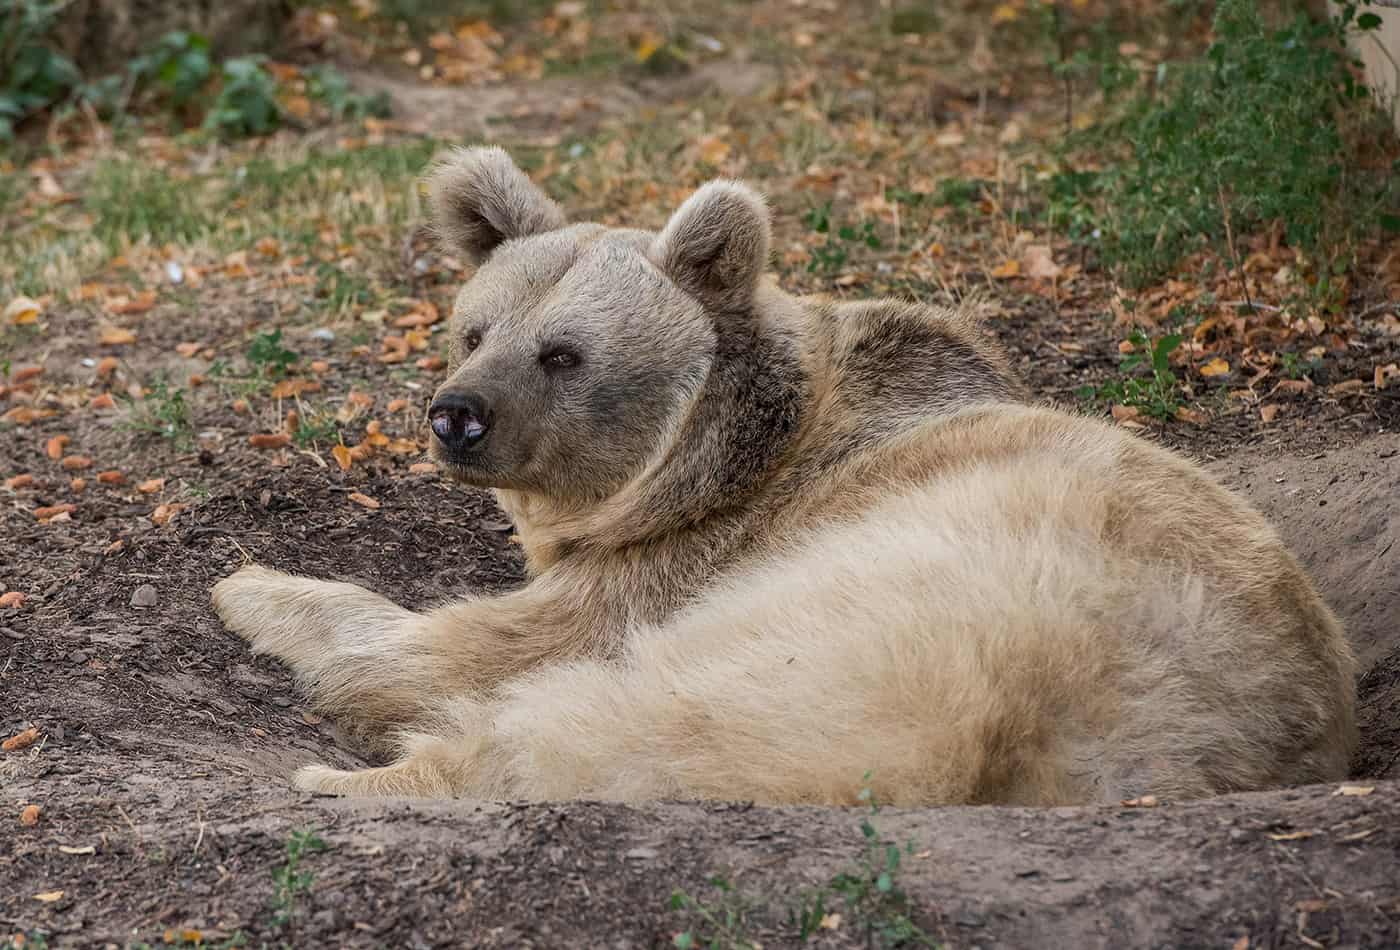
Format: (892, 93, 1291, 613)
(427, 146, 567, 264)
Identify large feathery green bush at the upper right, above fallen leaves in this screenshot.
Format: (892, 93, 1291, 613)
(1046, 0, 1400, 295)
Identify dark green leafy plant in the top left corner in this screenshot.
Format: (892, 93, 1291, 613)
(0, 0, 81, 141)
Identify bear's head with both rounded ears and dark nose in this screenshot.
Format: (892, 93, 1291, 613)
(428, 148, 769, 502)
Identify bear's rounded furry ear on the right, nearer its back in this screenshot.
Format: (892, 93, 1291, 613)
(651, 180, 770, 311)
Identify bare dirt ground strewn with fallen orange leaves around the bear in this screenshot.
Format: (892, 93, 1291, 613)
(8, 0, 1400, 950)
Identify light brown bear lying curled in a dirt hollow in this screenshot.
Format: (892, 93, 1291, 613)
(213, 148, 1355, 804)
